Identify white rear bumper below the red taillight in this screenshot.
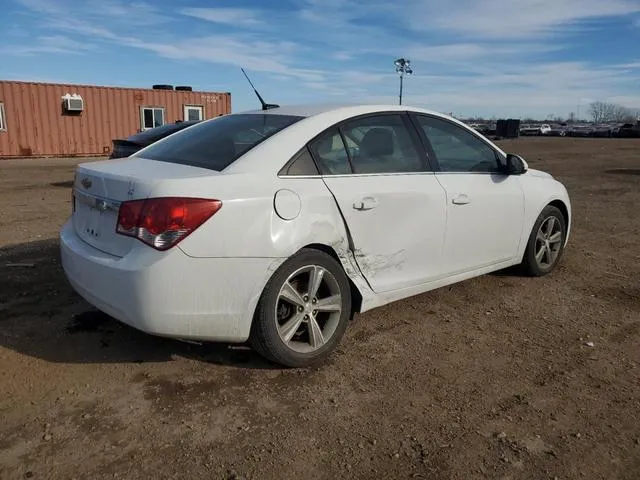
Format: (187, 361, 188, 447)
(60, 222, 282, 342)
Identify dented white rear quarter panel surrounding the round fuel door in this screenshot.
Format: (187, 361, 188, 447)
(170, 173, 375, 312)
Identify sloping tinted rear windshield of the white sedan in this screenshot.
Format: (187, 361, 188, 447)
(134, 113, 303, 171)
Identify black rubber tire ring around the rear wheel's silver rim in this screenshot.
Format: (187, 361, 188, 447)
(250, 249, 351, 367)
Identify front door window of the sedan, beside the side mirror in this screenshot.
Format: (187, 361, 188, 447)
(418, 116, 503, 173)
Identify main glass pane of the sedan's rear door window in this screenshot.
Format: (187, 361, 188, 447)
(340, 115, 426, 174)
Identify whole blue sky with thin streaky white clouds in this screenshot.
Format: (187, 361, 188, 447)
(0, 0, 640, 118)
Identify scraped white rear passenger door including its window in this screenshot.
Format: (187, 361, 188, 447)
(309, 112, 446, 292)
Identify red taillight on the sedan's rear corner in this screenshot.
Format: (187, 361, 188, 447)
(116, 197, 222, 250)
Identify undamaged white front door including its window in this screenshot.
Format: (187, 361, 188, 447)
(412, 115, 524, 276)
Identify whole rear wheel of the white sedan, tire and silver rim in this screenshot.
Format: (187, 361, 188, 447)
(249, 249, 351, 367)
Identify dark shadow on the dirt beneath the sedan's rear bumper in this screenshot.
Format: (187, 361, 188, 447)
(0, 240, 280, 369)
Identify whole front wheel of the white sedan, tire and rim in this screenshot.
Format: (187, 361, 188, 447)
(521, 205, 567, 277)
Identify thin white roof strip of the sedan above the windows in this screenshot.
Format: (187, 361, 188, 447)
(238, 103, 446, 117)
